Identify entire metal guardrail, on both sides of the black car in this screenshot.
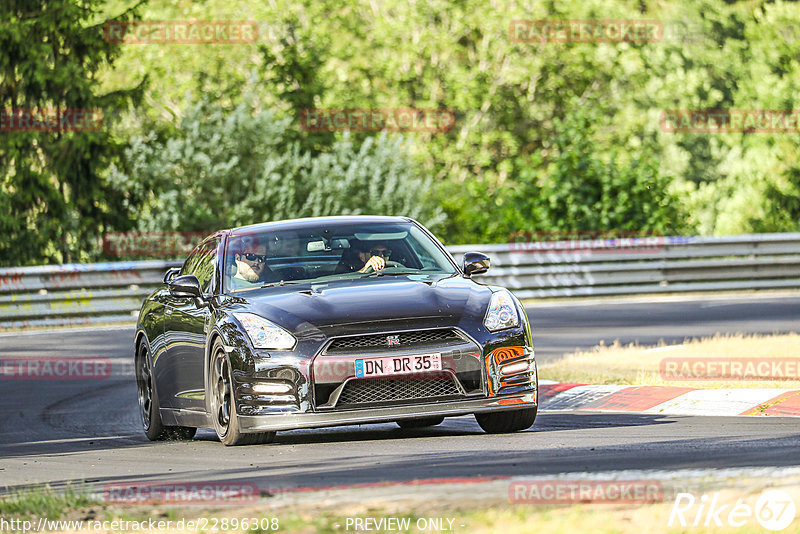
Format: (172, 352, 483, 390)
(0, 233, 800, 328)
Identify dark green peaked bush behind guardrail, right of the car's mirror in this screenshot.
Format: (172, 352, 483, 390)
(434, 106, 691, 243)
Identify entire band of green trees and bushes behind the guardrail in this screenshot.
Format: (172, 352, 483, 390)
(0, 0, 800, 264)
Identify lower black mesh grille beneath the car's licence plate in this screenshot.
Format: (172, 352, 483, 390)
(336, 377, 461, 407)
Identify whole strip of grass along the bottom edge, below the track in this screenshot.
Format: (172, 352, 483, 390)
(0, 476, 800, 534)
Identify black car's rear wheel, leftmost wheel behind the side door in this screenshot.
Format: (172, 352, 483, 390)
(135, 341, 197, 441)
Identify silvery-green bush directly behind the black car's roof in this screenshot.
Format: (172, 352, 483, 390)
(112, 99, 442, 231)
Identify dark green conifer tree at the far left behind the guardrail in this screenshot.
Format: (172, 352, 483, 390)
(0, 0, 144, 265)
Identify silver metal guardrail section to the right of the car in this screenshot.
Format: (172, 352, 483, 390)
(450, 233, 800, 298)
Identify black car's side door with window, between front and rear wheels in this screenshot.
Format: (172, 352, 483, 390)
(159, 238, 219, 411)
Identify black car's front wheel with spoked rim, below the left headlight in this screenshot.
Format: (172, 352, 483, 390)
(207, 339, 275, 446)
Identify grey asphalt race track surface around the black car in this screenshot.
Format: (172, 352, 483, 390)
(0, 295, 800, 490)
